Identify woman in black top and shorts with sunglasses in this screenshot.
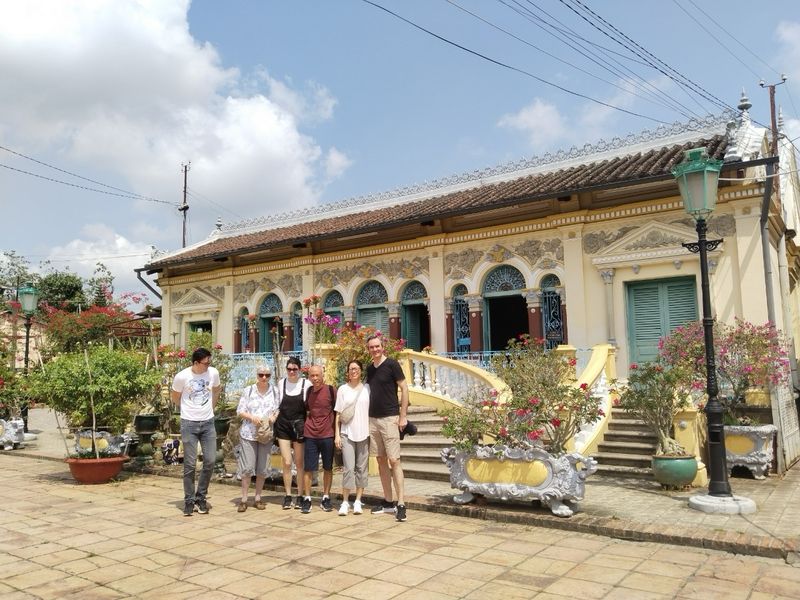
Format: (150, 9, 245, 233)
(275, 356, 311, 510)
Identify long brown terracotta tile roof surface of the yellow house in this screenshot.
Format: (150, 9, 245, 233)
(146, 135, 727, 269)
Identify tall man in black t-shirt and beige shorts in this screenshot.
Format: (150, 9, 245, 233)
(367, 335, 408, 521)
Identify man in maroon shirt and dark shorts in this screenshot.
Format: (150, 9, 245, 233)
(300, 365, 336, 513)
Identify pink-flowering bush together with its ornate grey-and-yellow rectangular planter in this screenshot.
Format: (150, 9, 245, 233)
(442, 335, 602, 517)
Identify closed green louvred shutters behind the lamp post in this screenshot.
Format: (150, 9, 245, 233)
(628, 278, 697, 362)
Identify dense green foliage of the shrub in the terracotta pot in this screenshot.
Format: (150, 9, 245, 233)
(29, 346, 161, 448)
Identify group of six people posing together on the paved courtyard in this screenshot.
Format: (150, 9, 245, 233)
(172, 336, 408, 521)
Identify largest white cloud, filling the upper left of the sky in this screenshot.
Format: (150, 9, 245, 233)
(0, 0, 350, 255)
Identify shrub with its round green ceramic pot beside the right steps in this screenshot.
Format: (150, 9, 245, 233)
(615, 358, 697, 488)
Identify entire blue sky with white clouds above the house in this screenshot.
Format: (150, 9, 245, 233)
(0, 0, 800, 290)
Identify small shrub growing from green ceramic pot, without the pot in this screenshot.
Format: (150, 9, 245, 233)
(615, 359, 691, 456)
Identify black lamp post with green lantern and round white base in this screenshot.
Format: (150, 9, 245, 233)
(672, 148, 756, 514)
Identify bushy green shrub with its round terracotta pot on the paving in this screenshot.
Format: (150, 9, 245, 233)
(29, 345, 161, 483)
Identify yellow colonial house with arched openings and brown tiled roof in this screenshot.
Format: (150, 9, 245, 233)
(145, 97, 798, 380)
